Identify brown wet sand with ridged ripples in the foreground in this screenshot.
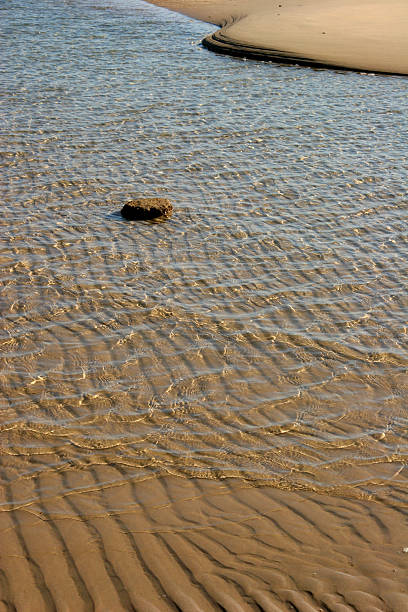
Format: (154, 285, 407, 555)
(0, 474, 408, 612)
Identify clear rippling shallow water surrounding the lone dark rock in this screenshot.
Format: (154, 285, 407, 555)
(0, 0, 408, 516)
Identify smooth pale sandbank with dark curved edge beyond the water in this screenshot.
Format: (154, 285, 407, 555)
(145, 0, 408, 74)
